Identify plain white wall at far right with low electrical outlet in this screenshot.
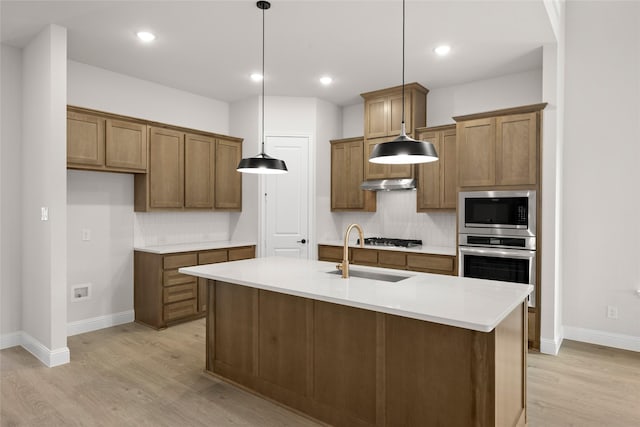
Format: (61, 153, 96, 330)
(562, 2, 640, 351)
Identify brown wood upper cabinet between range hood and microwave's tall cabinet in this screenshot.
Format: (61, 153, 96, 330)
(416, 125, 458, 212)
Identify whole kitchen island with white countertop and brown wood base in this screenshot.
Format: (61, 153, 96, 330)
(180, 257, 532, 426)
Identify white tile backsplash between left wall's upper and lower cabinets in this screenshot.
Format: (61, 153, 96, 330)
(133, 212, 230, 247)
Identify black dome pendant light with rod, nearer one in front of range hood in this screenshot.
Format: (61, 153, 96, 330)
(369, 0, 438, 165)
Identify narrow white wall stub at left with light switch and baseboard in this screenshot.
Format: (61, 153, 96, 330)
(22, 25, 69, 366)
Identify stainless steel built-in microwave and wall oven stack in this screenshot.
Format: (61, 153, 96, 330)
(458, 191, 537, 307)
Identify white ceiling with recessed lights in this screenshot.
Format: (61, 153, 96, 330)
(0, 0, 554, 105)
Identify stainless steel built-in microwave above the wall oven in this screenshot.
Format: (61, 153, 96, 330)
(458, 190, 536, 237)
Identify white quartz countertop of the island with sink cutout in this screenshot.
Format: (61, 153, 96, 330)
(179, 257, 533, 332)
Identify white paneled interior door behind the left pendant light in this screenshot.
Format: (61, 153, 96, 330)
(264, 136, 310, 258)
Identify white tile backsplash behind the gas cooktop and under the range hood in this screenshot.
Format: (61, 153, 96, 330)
(326, 191, 456, 248)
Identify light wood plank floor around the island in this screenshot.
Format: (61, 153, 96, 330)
(0, 320, 640, 427)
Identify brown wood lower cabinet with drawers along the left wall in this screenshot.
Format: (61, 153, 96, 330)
(133, 246, 255, 329)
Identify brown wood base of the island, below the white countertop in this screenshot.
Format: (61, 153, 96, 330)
(206, 280, 527, 427)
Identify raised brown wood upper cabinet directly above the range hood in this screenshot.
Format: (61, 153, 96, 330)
(360, 83, 429, 180)
